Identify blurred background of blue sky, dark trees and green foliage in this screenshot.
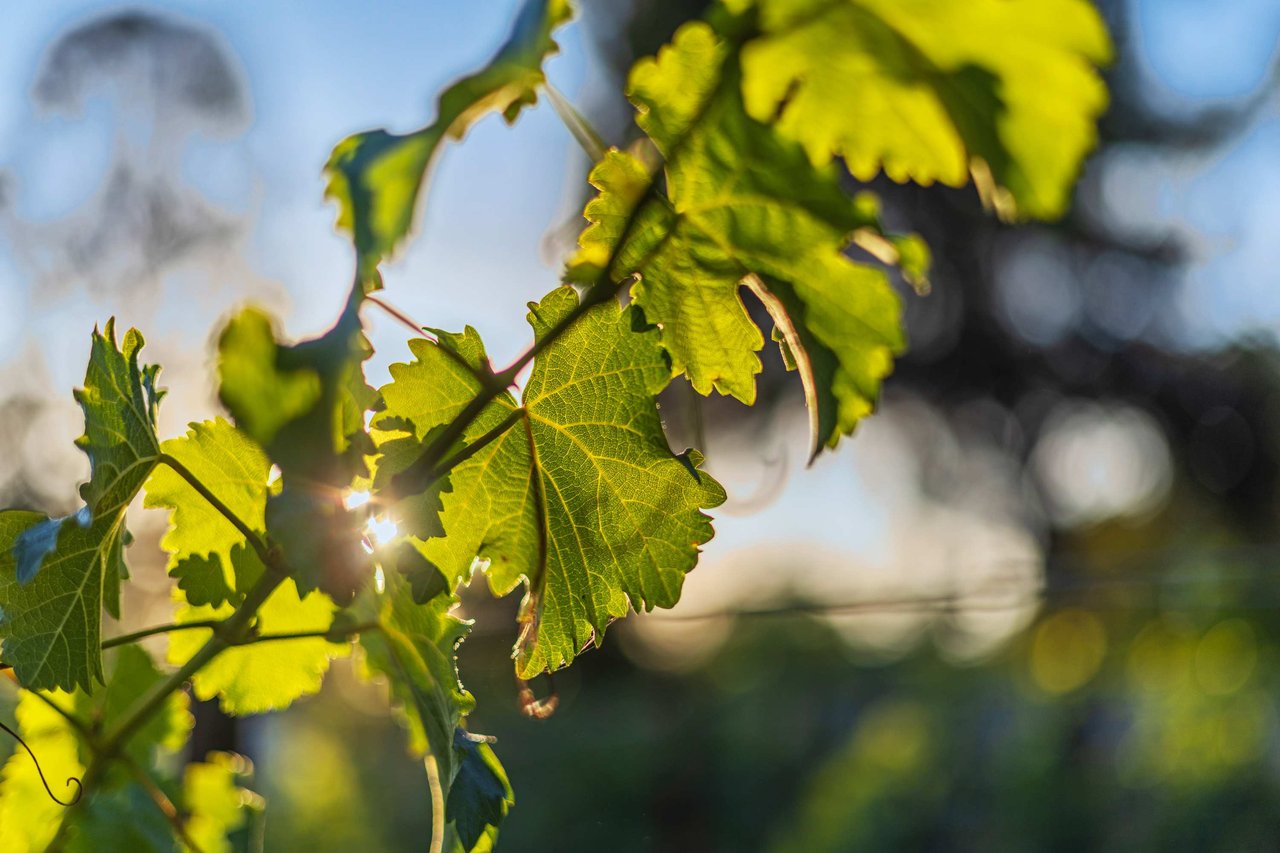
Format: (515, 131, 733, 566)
(0, 0, 1280, 853)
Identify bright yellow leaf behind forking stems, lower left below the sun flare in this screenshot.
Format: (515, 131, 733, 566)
(169, 580, 351, 715)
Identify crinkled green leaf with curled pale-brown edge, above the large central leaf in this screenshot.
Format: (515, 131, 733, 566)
(568, 23, 906, 453)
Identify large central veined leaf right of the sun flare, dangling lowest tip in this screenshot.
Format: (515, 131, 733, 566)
(375, 288, 724, 678)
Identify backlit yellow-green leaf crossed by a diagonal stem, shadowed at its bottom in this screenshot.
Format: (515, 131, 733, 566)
(143, 418, 271, 607)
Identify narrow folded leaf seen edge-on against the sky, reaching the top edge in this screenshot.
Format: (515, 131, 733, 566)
(325, 0, 572, 289)
